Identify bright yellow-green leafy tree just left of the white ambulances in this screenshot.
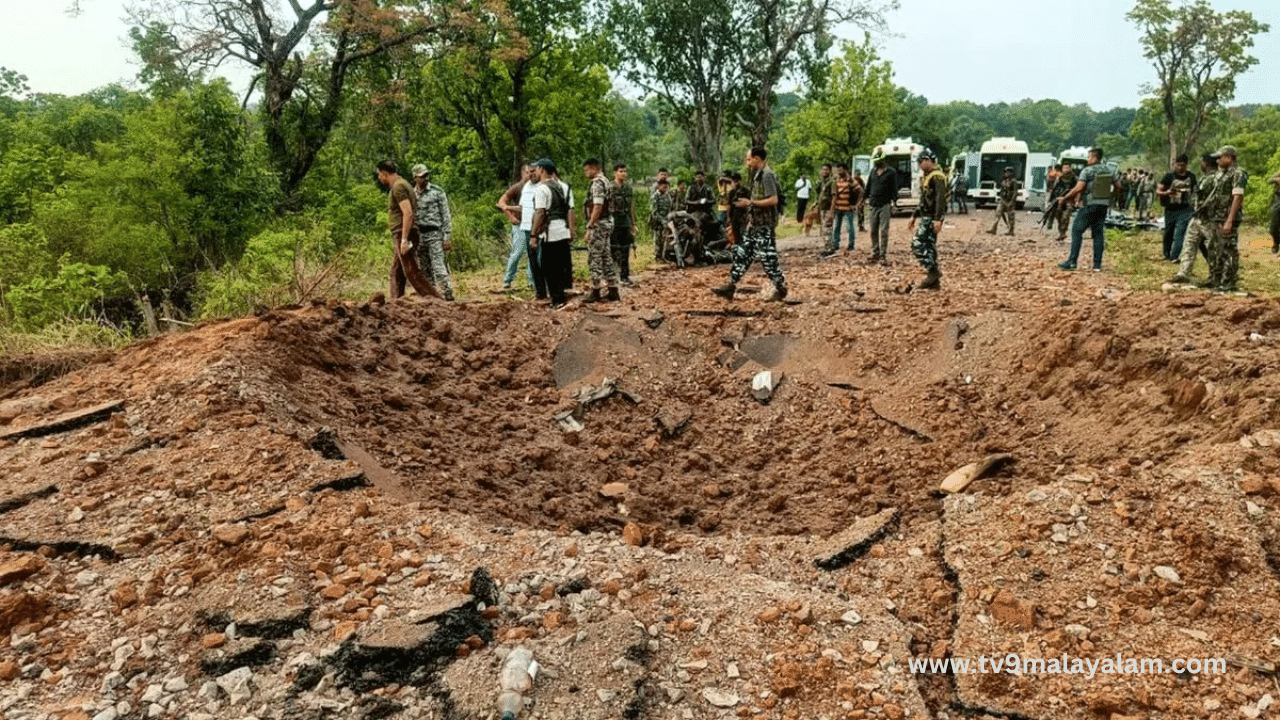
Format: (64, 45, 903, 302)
(785, 35, 895, 160)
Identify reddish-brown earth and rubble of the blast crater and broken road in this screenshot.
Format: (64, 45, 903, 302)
(0, 228, 1280, 720)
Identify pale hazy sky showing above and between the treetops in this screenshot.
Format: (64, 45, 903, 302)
(0, 0, 1280, 110)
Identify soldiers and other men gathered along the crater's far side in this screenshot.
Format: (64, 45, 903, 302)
(378, 145, 1280, 302)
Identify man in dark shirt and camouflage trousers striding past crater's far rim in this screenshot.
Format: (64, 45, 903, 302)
(712, 147, 787, 301)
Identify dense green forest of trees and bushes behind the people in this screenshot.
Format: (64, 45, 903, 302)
(0, 0, 1280, 337)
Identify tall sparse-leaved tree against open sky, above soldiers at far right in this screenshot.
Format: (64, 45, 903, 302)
(1126, 0, 1271, 163)
